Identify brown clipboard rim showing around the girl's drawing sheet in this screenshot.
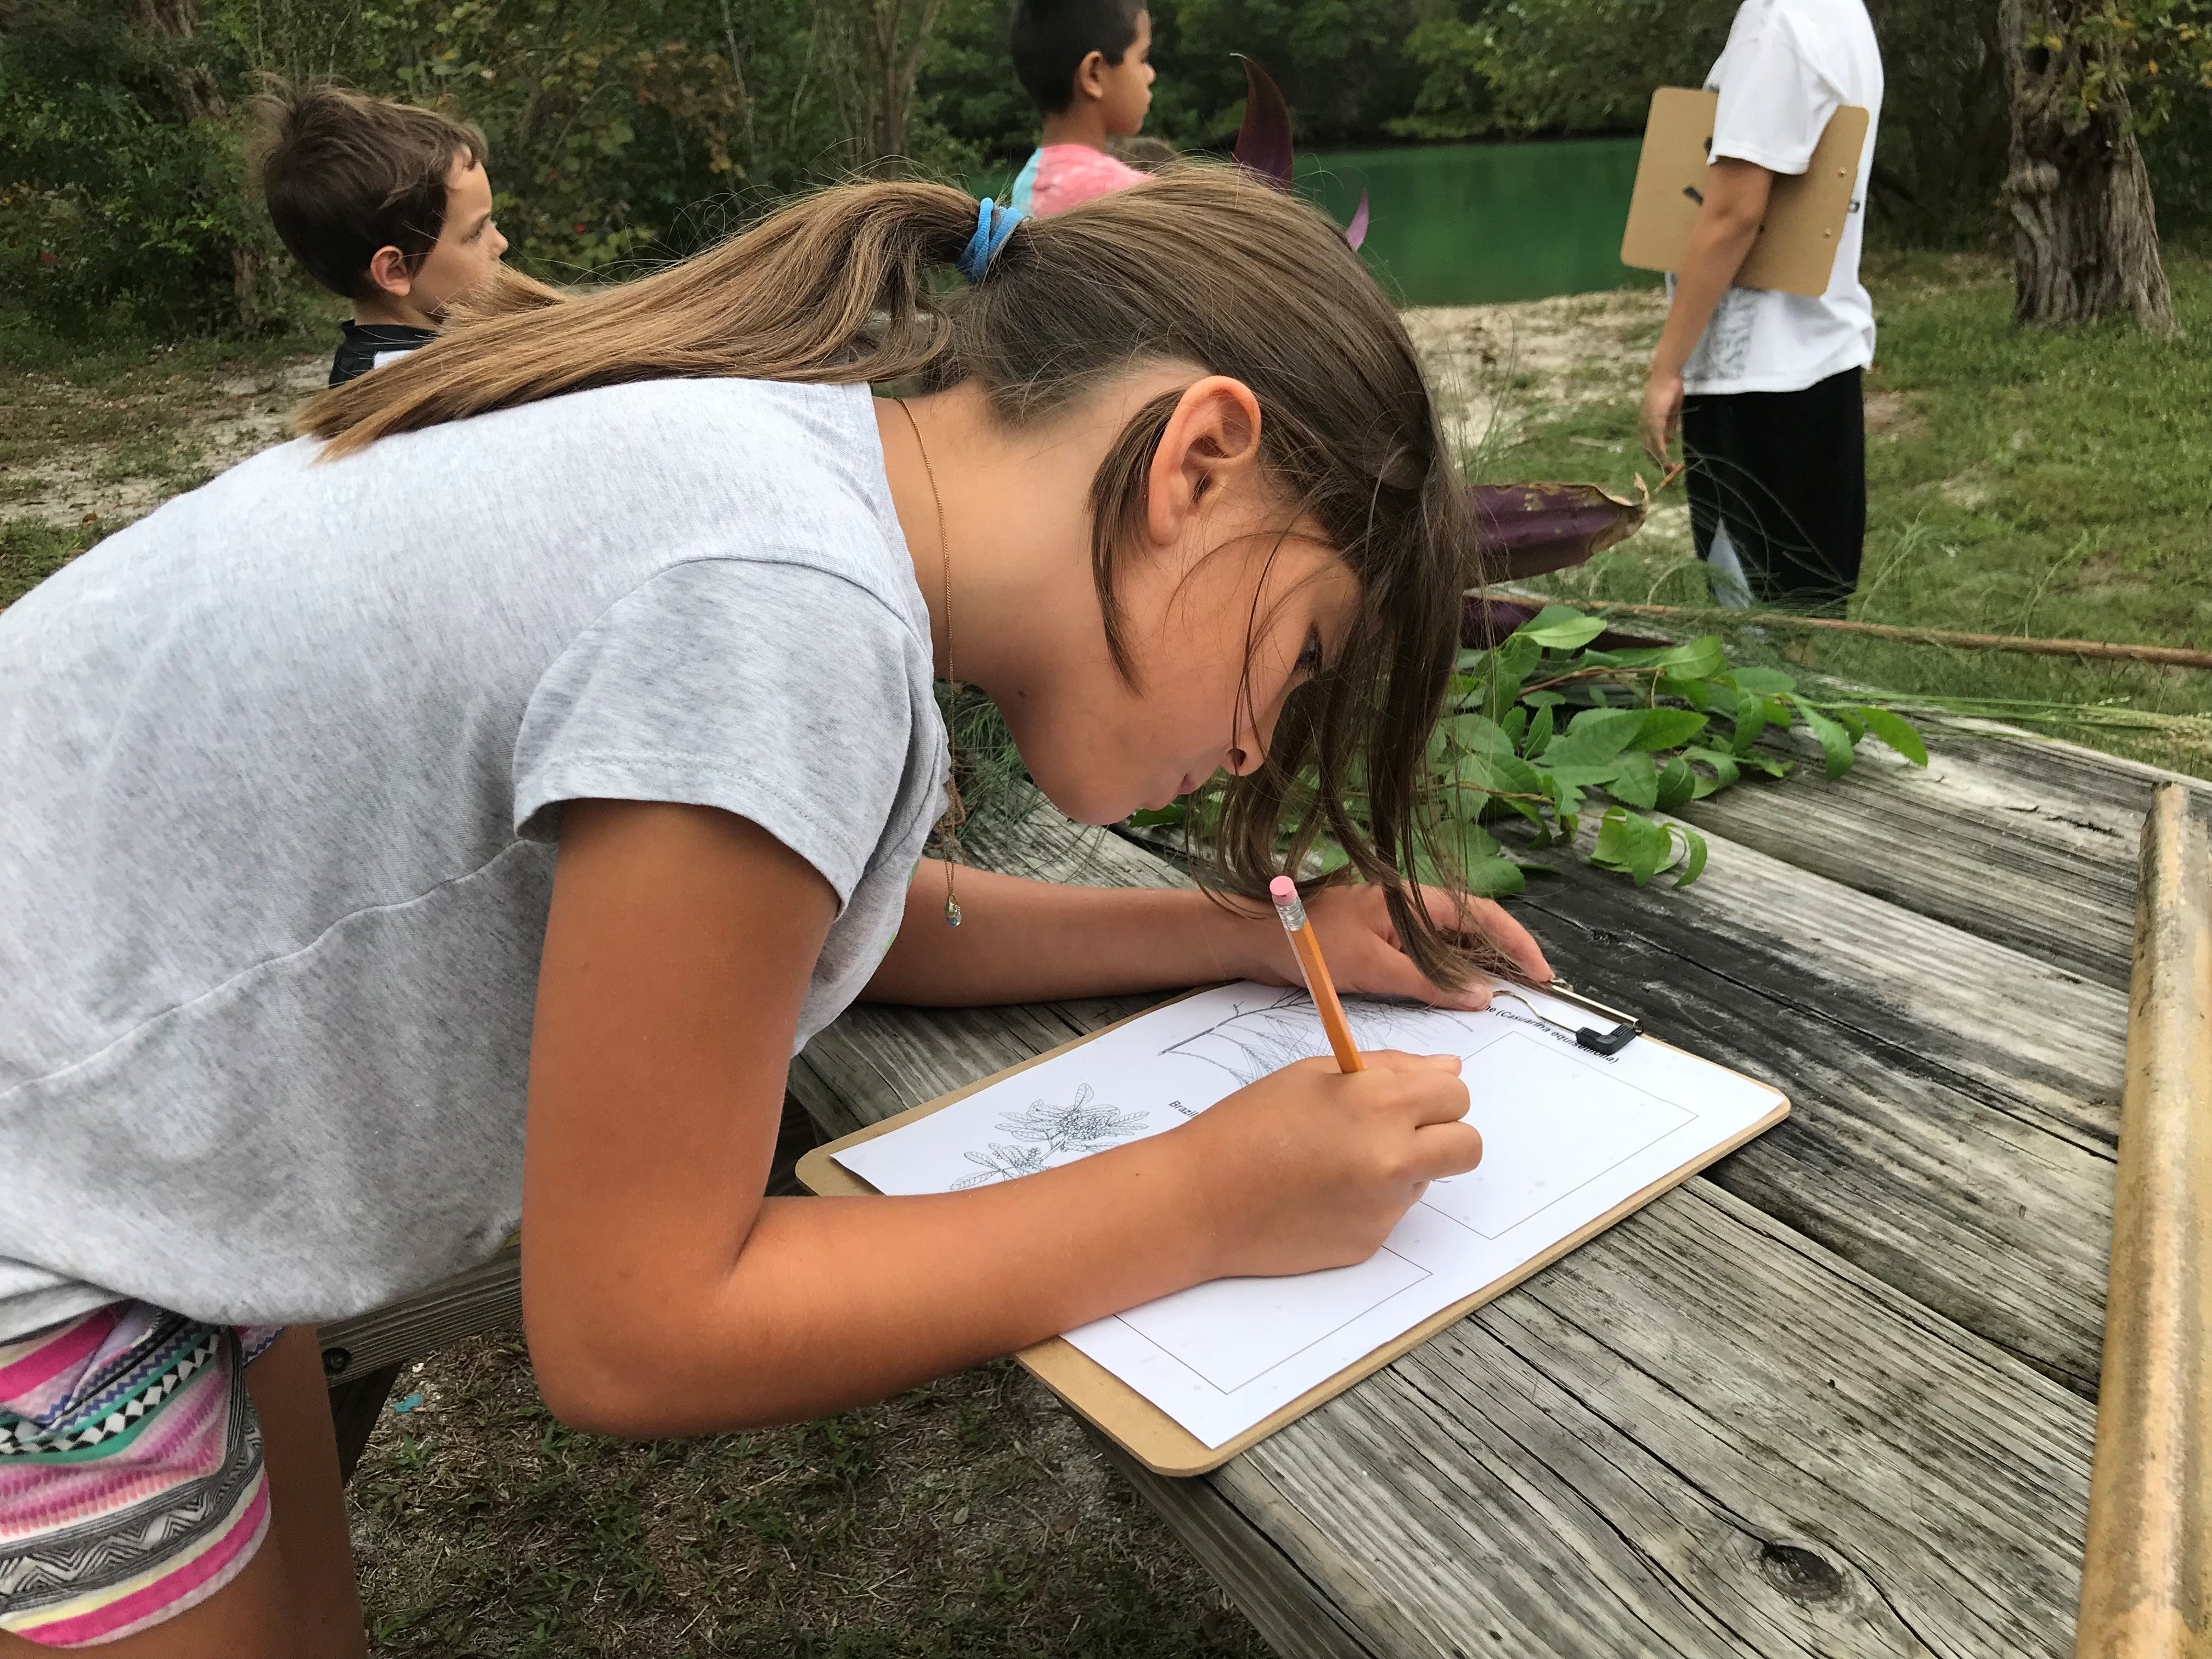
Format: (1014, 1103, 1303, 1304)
(799, 986, 1790, 1475)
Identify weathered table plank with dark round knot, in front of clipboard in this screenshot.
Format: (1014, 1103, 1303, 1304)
(1207, 1181, 2090, 1657)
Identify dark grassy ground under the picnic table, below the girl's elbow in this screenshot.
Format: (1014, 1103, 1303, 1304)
(349, 1336, 1267, 1659)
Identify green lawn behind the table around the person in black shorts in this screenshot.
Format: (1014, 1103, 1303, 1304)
(1484, 252, 2212, 774)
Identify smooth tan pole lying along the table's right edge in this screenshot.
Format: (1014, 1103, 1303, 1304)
(2075, 785, 2212, 1659)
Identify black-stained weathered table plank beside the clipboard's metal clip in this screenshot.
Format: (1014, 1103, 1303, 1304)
(1526, 836, 2126, 1396)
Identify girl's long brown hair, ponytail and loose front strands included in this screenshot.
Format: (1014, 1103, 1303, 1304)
(301, 166, 1475, 984)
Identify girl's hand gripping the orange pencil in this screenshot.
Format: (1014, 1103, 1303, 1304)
(1161, 1053, 1482, 1276)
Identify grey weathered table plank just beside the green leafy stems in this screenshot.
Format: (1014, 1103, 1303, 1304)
(1681, 725, 2212, 989)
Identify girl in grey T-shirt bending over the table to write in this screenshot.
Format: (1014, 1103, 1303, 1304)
(0, 168, 1548, 1659)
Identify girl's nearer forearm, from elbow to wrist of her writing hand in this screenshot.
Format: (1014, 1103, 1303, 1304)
(549, 1132, 1217, 1438)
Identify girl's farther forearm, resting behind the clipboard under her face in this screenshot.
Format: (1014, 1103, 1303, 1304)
(865, 858, 1256, 1009)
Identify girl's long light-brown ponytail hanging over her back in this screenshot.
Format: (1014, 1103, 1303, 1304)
(298, 184, 975, 458)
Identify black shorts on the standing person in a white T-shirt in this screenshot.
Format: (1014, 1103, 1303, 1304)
(1681, 369, 1867, 617)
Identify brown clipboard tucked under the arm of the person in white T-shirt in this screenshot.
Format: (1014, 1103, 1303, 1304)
(1621, 86, 1867, 294)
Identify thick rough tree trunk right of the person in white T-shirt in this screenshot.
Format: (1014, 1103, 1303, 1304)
(2002, 0, 2174, 334)
